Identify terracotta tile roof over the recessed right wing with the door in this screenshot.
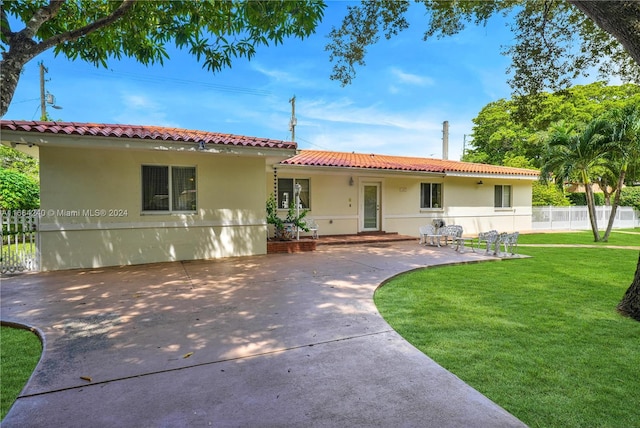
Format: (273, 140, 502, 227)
(280, 150, 539, 177)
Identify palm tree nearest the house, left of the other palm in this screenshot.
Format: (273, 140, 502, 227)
(541, 119, 611, 242)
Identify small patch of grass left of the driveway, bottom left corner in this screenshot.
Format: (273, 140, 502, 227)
(0, 326, 42, 420)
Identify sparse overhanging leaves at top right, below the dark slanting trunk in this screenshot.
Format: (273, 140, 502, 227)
(326, 0, 640, 94)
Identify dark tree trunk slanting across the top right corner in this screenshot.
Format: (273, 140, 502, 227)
(569, 0, 640, 64)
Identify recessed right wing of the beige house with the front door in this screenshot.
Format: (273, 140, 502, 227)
(267, 150, 538, 235)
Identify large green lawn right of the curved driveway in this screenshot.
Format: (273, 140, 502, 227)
(375, 229, 640, 428)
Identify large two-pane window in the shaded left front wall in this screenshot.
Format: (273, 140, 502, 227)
(142, 165, 196, 212)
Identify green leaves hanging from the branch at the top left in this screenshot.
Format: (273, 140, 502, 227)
(0, 0, 326, 116)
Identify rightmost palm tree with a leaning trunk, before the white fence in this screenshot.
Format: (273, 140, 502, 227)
(602, 105, 640, 241)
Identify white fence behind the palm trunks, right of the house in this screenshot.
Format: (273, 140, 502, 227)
(532, 206, 640, 230)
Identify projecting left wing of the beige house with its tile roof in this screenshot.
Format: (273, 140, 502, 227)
(0, 120, 296, 270)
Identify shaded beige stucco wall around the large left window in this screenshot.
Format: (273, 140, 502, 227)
(40, 146, 266, 270)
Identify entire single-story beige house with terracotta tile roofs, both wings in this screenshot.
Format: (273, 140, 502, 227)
(0, 120, 537, 270)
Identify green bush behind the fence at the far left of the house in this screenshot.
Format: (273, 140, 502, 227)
(0, 168, 40, 210)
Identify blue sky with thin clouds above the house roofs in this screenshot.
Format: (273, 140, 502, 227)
(4, 2, 544, 160)
